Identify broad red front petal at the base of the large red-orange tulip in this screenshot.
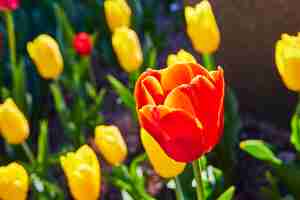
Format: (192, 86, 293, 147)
(140, 106, 205, 162)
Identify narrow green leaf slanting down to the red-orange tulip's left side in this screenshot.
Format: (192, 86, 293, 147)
(107, 75, 135, 112)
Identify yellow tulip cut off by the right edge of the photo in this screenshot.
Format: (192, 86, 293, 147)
(275, 33, 300, 92)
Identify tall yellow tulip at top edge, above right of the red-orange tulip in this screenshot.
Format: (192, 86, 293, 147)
(185, 0, 220, 54)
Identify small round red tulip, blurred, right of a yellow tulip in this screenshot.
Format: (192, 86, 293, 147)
(73, 32, 93, 56)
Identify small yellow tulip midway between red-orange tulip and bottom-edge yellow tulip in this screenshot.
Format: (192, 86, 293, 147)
(95, 125, 127, 166)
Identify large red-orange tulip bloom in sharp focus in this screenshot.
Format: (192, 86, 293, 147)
(135, 63, 225, 162)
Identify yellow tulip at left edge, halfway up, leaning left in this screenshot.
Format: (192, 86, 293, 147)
(0, 98, 29, 144)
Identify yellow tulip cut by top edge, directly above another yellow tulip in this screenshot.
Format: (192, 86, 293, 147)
(104, 0, 131, 32)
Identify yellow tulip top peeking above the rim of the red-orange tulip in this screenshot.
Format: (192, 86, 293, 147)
(167, 49, 197, 67)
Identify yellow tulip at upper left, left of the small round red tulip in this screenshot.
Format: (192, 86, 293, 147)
(27, 34, 63, 79)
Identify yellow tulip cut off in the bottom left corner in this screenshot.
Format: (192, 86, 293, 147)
(0, 163, 29, 200)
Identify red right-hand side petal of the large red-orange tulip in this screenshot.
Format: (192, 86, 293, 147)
(179, 71, 224, 152)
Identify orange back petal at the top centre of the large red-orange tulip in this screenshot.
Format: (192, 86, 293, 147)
(161, 64, 193, 93)
